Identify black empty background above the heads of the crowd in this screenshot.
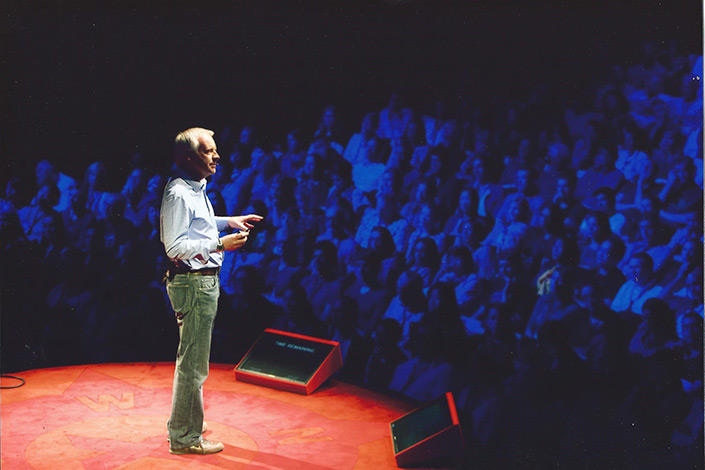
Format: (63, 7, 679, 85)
(0, 0, 702, 186)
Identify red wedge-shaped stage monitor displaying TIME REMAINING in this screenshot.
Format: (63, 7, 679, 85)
(235, 329, 343, 395)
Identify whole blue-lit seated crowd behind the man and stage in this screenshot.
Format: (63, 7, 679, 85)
(0, 40, 703, 468)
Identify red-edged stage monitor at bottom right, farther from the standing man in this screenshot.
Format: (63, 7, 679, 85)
(390, 392, 464, 467)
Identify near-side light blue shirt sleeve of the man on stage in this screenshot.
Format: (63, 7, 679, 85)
(160, 189, 218, 263)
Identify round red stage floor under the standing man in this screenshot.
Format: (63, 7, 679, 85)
(0, 363, 418, 470)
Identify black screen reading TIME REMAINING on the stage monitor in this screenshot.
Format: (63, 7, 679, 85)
(237, 331, 335, 384)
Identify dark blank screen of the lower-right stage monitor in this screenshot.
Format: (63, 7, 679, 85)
(390, 395, 453, 454)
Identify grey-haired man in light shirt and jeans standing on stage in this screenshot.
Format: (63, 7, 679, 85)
(160, 128, 262, 454)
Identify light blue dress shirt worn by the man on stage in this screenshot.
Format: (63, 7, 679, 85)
(159, 171, 228, 270)
